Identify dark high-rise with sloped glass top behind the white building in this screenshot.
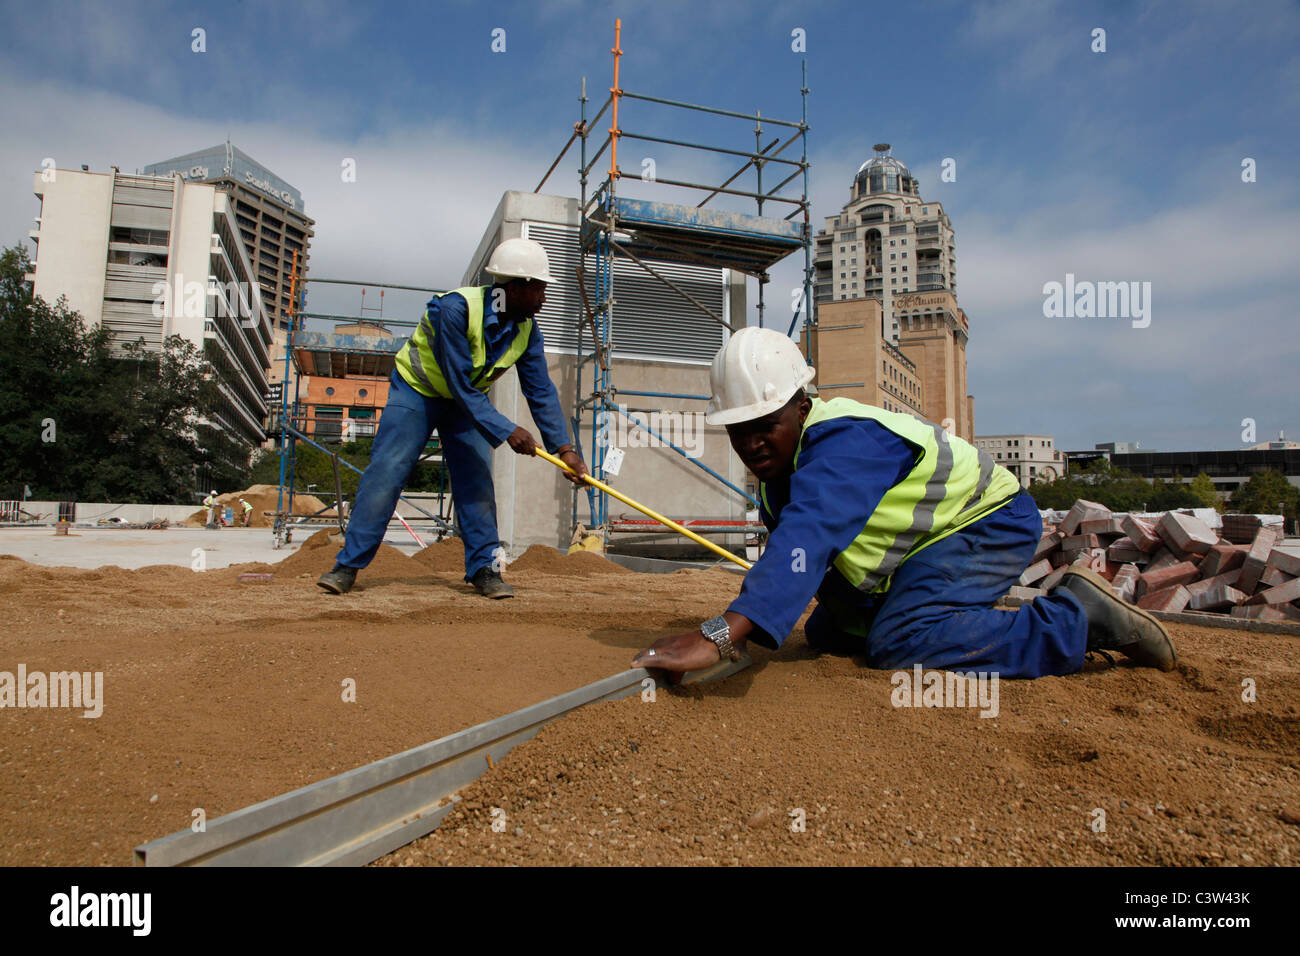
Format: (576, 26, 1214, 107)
(144, 142, 316, 329)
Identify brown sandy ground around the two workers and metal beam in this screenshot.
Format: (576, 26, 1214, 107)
(0, 528, 1300, 866)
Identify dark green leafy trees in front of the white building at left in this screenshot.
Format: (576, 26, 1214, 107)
(0, 246, 248, 503)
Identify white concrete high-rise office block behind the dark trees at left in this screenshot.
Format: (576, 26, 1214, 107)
(27, 169, 272, 445)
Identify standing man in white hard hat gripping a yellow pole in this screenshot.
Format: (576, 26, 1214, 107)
(317, 239, 586, 598)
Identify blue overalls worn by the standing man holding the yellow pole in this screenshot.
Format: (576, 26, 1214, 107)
(335, 287, 569, 581)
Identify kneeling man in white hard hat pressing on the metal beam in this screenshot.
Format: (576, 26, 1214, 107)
(633, 328, 1175, 678)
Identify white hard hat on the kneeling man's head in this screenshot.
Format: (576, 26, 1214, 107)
(705, 326, 813, 425)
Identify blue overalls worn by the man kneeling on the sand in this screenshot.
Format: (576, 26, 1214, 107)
(728, 419, 1088, 678)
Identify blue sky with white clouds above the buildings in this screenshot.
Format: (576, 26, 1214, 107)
(0, 0, 1300, 450)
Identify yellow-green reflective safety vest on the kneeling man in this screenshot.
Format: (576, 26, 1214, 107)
(761, 398, 1021, 592)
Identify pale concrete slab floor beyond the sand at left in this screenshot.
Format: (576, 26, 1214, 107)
(0, 525, 423, 570)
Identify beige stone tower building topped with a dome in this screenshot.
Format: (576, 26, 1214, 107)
(803, 143, 975, 440)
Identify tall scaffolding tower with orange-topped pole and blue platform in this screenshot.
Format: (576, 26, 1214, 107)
(537, 21, 813, 546)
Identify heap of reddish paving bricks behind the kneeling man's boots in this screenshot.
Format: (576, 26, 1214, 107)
(1011, 499, 1300, 620)
